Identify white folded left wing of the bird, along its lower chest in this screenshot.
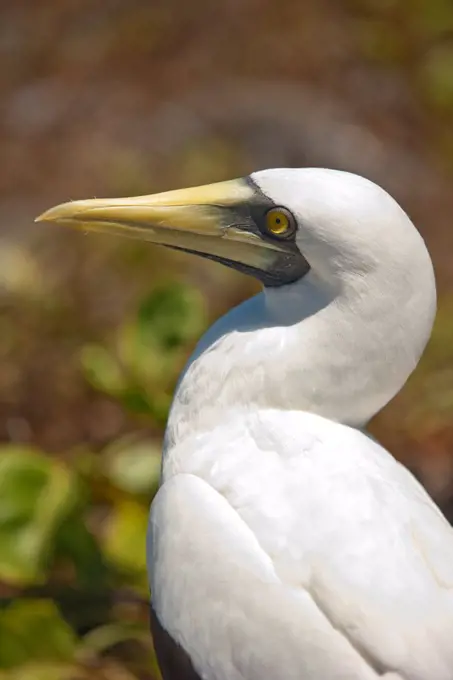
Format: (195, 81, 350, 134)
(148, 474, 382, 680)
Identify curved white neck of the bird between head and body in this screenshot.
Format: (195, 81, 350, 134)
(166, 266, 432, 447)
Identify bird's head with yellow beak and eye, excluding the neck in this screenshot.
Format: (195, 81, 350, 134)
(37, 168, 432, 298)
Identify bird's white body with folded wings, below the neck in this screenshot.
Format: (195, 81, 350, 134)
(149, 414, 453, 680)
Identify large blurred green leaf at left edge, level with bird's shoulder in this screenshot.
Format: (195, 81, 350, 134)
(0, 445, 78, 584)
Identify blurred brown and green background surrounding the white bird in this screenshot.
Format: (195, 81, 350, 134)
(0, 0, 453, 680)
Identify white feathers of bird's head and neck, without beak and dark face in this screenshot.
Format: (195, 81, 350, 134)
(163, 168, 436, 452)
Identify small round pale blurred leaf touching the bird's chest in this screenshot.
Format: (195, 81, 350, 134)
(103, 437, 160, 494)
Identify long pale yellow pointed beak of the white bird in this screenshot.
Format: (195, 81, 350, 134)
(36, 179, 308, 285)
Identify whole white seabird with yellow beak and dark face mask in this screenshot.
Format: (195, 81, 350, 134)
(39, 168, 453, 680)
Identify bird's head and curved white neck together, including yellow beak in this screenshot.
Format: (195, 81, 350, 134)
(38, 168, 436, 429)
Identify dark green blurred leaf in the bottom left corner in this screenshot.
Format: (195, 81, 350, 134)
(0, 600, 77, 668)
